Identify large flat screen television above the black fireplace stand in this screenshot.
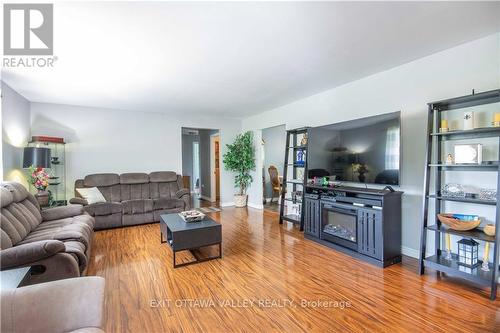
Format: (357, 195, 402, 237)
(307, 112, 401, 185)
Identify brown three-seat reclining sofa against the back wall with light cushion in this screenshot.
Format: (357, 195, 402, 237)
(70, 171, 191, 230)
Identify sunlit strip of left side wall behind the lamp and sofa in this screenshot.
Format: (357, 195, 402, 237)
(2, 82, 30, 186)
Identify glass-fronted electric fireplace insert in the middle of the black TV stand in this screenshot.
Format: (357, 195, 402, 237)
(321, 200, 358, 250)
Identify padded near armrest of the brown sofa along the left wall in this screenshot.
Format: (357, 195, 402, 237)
(0, 240, 66, 269)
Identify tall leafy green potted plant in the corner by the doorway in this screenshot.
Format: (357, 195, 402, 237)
(222, 131, 255, 207)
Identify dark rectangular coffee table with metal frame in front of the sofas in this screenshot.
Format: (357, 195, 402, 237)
(160, 213, 222, 268)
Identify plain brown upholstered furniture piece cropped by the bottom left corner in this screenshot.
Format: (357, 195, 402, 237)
(1, 276, 105, 332)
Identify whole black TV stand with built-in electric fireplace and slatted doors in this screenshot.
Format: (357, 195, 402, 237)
(304, 185, 403, 267)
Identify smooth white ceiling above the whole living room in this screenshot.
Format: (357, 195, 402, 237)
(2, 2, 500, 117)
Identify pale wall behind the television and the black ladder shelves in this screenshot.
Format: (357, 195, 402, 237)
(243, 34, 500, 255)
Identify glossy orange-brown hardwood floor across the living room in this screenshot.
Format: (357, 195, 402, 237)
(88, 208, 500, 332)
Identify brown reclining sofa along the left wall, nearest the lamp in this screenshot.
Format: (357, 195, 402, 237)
(0, 182, 94, 284)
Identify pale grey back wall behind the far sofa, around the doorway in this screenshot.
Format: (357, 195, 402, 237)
(31, 103, 241, 205)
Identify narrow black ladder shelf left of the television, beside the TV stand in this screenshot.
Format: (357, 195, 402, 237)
(280, 127, 308, 231)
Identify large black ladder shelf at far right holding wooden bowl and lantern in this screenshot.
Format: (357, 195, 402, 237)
(419, 89, 500, 300)
